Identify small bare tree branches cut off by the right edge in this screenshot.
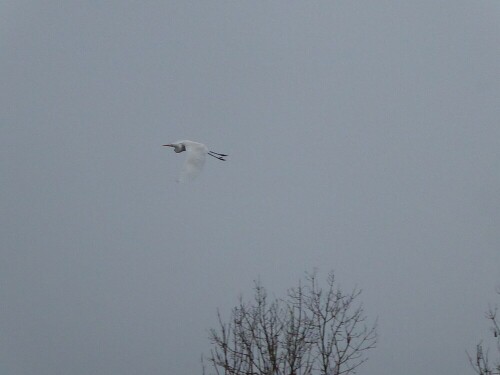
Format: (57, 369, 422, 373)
(467, 287, 500, 375)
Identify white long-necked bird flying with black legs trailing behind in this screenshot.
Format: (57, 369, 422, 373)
(163, 141, 227, 182)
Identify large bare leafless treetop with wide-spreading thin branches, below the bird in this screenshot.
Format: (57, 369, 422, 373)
(203, 272, 377, 375)
